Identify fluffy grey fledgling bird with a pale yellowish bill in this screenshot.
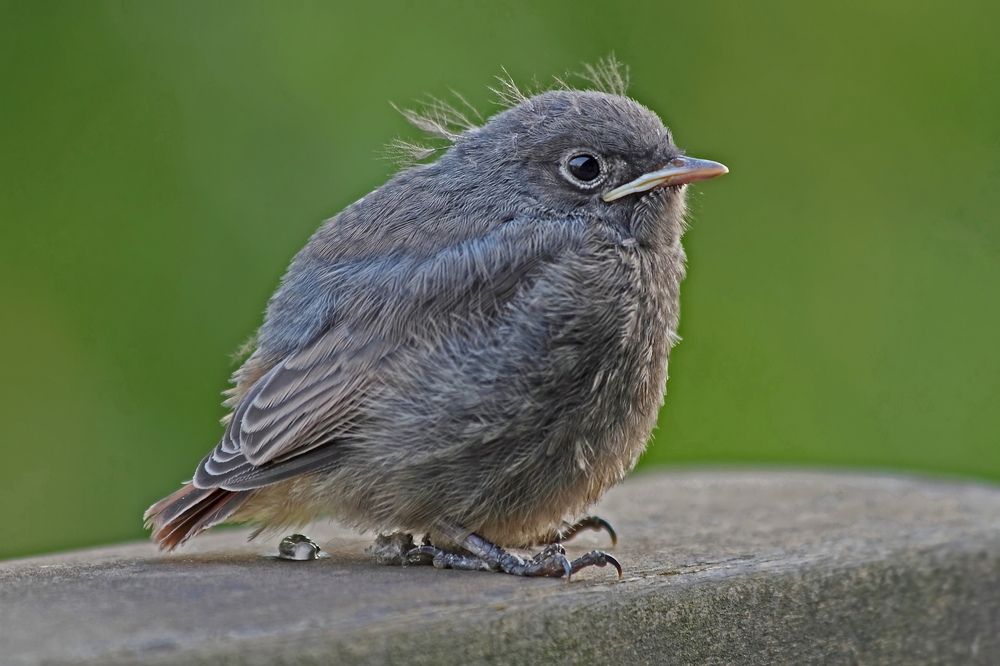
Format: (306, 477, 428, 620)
(145, 76, 727, 577)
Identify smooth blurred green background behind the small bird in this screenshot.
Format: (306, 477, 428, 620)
(0, 0, 1000, 557)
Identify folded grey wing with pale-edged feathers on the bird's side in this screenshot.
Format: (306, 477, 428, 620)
(194, 215, 584, 490)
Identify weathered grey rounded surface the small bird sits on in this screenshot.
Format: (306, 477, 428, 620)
(0, 470, 1000, 665)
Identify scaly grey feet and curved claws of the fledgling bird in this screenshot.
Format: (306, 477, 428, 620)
(407, 527, 622, 580)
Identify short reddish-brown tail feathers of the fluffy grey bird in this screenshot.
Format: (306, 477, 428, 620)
(143, 483, 253, 550)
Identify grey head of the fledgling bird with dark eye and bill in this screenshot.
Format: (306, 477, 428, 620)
(446, 90, 728, 235)
